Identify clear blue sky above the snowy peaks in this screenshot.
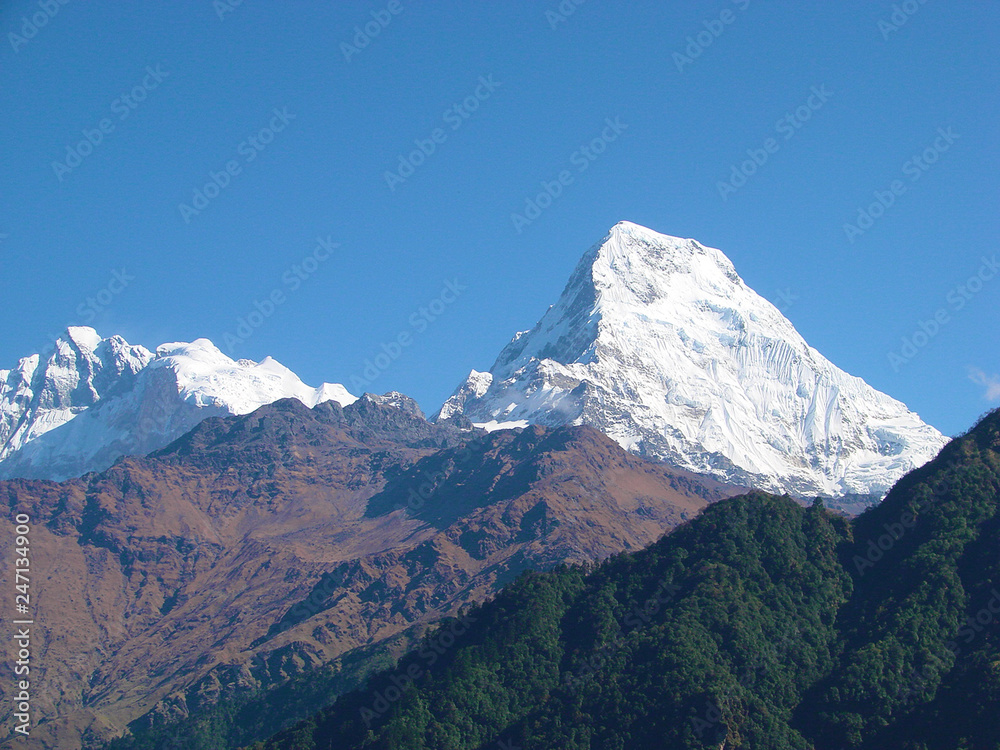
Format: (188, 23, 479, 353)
(0, 0, 1000, 433)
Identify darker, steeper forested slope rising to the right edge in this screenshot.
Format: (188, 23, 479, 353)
(800, 412, 1000, 750)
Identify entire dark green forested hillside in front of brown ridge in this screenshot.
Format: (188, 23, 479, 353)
(254, 412, 1000, 750)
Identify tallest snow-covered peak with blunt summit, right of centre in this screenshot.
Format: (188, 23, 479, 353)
(438, 222, 946, 497)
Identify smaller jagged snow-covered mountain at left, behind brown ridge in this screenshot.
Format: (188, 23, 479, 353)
(0, 327, 356, 480)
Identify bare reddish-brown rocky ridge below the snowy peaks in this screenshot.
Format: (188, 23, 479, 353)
(0, 394, 736, 749)
